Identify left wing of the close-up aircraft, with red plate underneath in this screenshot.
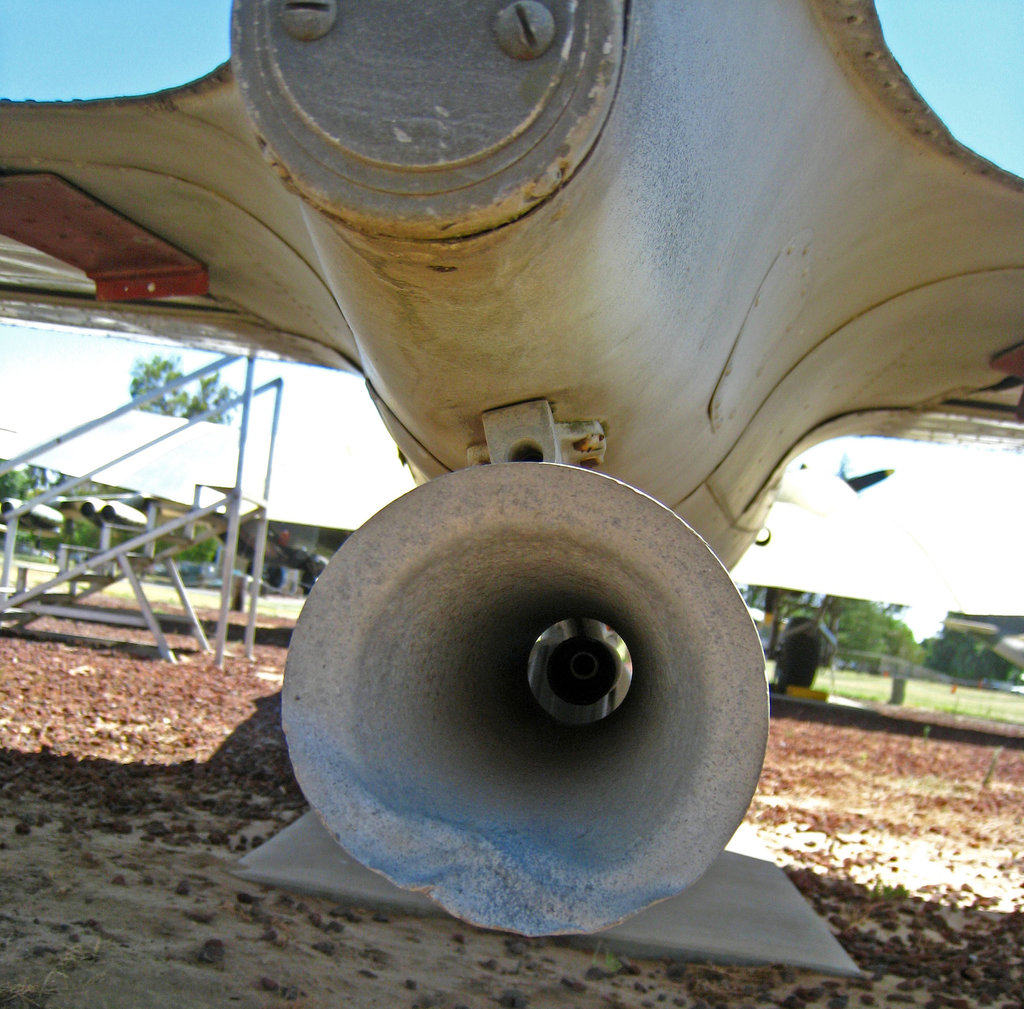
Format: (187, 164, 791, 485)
(0, 66, 358, 370)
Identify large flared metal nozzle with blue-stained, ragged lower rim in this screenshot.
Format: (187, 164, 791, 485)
(283, 463, 768, 935)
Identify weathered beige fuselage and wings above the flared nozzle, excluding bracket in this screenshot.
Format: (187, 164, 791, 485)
(0, 0, 1024, 562)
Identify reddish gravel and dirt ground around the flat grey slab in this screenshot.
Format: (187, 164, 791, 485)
(0, 627, 1024, 1009)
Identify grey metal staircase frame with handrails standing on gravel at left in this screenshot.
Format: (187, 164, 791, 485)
(0, 356, 284, 666)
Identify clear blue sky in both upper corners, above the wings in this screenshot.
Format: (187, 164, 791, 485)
(0, 0, 1024, 174)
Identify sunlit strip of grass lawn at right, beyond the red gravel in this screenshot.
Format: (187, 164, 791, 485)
(814, 669, 1024, 724)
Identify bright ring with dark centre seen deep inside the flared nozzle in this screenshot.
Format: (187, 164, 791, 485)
(528, 617, 633, 725)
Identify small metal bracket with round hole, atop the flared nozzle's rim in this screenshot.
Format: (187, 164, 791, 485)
(467, 400, 606, 469)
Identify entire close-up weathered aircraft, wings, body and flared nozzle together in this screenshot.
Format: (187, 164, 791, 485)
(0, 0, 1024, 932)
